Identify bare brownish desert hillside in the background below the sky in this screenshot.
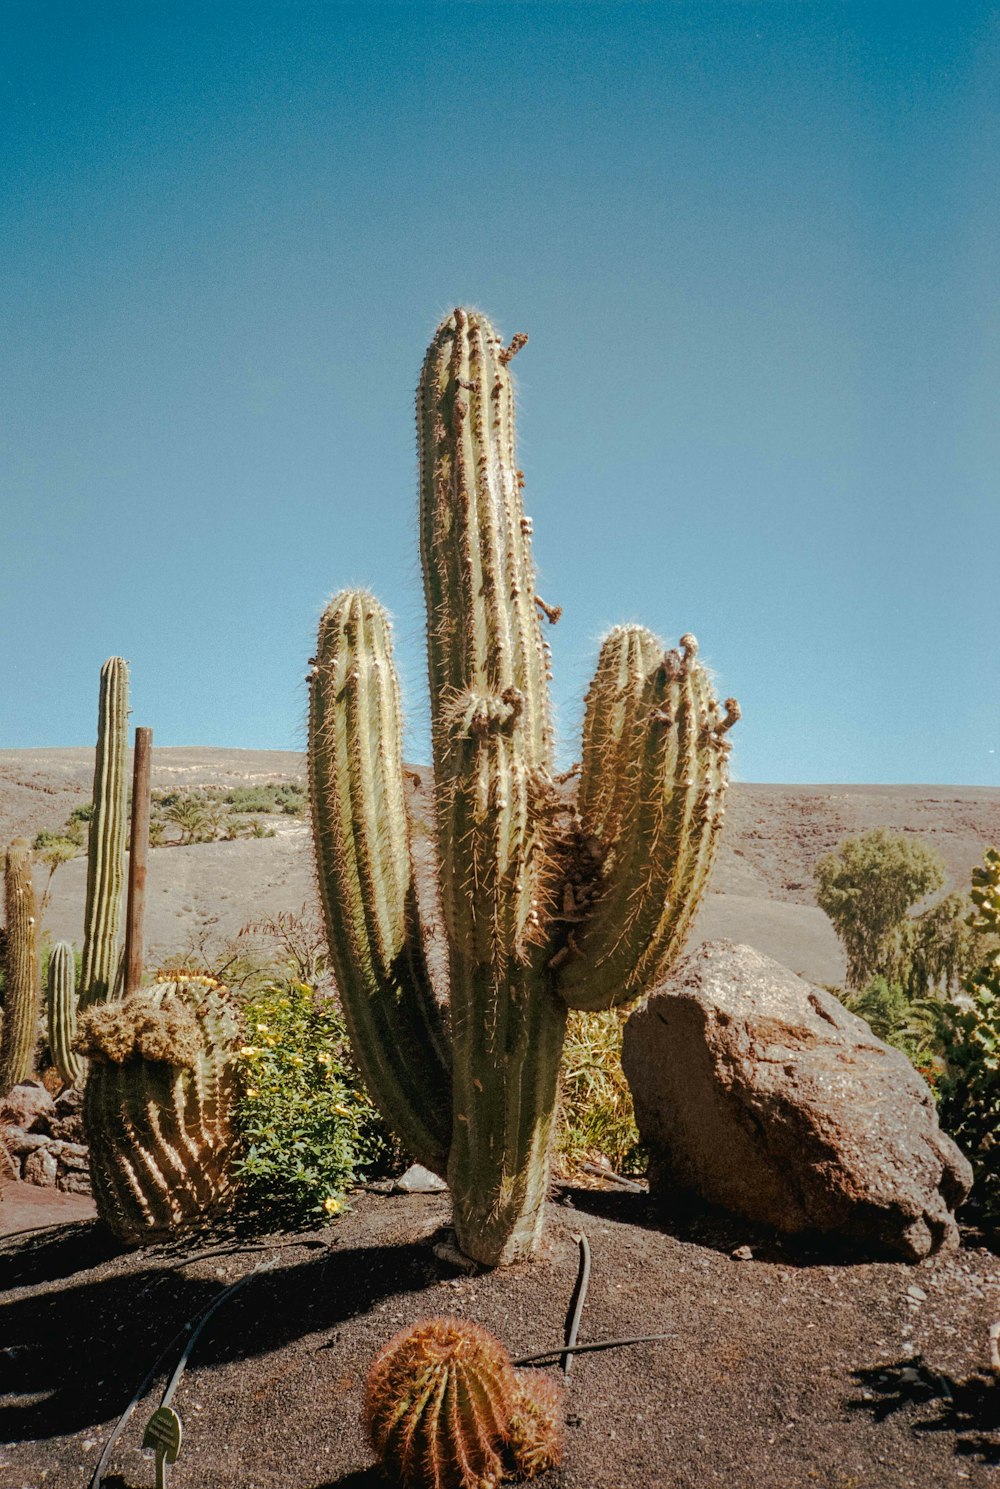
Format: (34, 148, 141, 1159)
(0, 747, 1000, 983)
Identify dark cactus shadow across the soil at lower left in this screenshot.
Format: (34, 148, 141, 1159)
(0, 1242, 436, 1443)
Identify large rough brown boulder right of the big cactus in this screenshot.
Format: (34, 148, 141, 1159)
(622, 941, 972, 1261)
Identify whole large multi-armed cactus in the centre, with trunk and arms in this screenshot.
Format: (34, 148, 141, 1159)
(310, 310, 740, 1266)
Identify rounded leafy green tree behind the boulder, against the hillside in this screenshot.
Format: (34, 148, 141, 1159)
(815, 828, 945, 989)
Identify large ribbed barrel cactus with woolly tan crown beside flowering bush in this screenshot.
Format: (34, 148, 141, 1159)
(76, 977, 240, 1245)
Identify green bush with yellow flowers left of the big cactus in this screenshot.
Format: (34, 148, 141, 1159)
(237, 983, 397, 1225)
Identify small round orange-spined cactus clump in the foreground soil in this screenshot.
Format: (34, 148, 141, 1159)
(363, 1318, 563, 1489)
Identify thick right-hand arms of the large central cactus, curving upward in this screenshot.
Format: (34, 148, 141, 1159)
(554, 633, 738, 1011)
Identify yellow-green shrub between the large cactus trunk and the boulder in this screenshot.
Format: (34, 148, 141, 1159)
(555, 1008, 646, 1178)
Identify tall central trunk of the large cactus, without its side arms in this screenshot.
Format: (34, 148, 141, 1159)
(417, 310, 565, 1264)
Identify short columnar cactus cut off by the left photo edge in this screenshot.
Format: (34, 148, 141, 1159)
(0, 838, 42, 1096)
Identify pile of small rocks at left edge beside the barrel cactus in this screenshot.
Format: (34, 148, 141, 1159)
(0, 1081, 91, 1194)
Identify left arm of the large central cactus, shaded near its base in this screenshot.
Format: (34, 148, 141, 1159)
(310, 591, 451, 1175)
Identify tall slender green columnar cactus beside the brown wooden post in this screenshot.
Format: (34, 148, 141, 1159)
(80, 657, 128, 1008)
